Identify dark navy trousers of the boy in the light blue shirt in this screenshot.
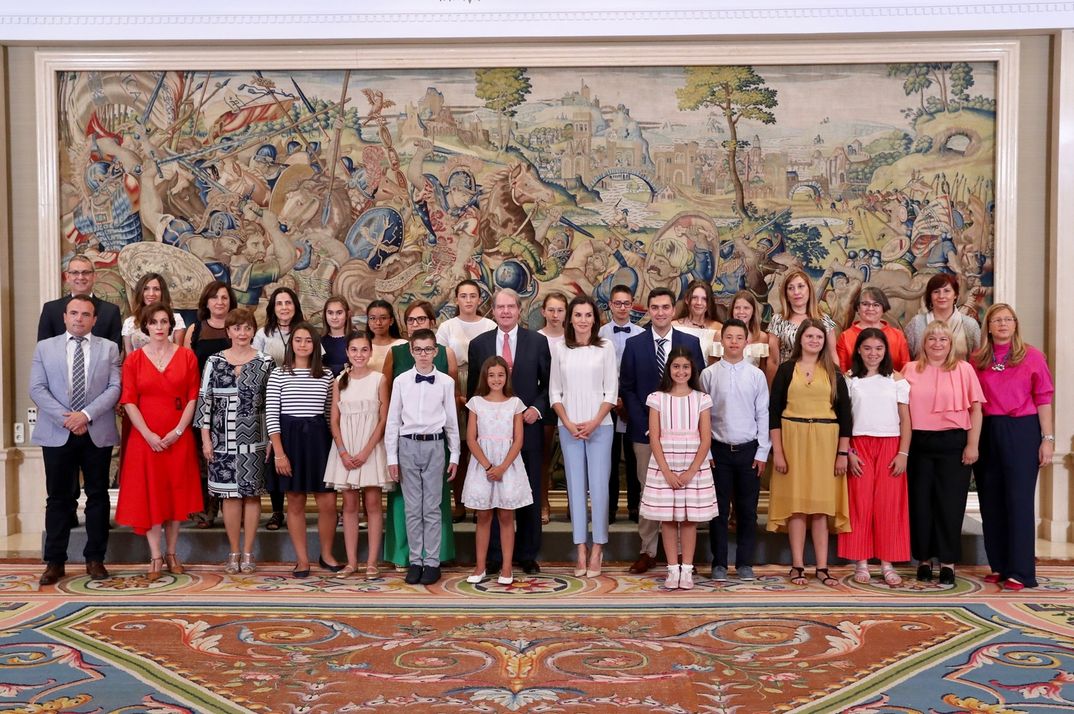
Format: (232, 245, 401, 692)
(709, 440, 760, 568)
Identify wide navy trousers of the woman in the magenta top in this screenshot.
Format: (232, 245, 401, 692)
(973, 414, 1041, 587)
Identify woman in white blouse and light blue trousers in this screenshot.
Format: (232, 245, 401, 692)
(549, 295, 619, 578)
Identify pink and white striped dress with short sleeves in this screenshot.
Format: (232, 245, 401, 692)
(639, 392, 717, 523)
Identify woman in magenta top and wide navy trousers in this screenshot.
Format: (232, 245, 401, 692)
(972, 303, 1056, 591)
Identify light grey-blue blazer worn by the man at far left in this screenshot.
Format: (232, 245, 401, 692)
(30, 331, 119, 447)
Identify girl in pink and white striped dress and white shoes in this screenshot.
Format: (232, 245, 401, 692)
(640, 347, 716, 591)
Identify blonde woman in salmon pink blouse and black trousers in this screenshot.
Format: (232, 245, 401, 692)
(903, 321, 985, 585)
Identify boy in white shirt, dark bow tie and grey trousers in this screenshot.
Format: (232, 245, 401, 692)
(384, 330, 459, 585)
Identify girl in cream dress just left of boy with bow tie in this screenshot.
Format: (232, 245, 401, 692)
(324, 333, 395, 580)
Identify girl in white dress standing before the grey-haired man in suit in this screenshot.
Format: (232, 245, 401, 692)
(463, 356, 534, 585)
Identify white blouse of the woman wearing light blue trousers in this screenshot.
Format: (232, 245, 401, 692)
(548, 339, 619, 425)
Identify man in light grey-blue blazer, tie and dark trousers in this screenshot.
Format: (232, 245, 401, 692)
(30, 294, 119, 585)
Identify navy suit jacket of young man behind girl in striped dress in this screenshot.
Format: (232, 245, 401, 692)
(619, 327, 705, 443)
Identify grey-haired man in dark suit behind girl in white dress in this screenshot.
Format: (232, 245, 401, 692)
(466, 290, 552, 575)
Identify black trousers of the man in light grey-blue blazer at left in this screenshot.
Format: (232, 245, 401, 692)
(41, 434, 112, 563)
